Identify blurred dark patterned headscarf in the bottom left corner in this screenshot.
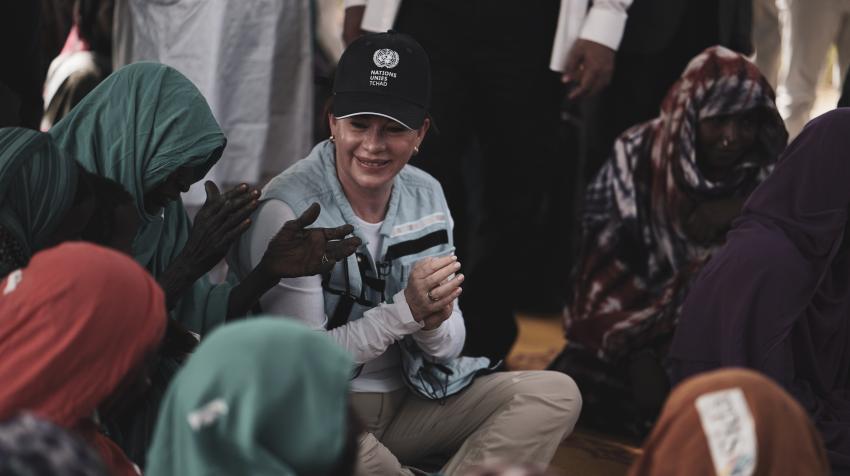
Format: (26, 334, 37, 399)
(0, 413, 109, 476)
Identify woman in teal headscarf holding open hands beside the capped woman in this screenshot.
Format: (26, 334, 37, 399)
(50, 63, 359, 334)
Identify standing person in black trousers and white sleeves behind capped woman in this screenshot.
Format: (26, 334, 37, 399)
(343, 0, 631, 362)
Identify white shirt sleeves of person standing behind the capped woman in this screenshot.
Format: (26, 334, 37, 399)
(345, 0, 632, 72)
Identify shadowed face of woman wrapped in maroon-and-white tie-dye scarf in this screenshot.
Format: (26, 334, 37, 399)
(696, 109, 761, 180)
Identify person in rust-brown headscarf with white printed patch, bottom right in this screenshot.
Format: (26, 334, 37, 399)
(629, 369, 830, 476)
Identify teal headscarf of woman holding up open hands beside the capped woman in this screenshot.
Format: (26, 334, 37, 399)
(50, 63, 230, 333)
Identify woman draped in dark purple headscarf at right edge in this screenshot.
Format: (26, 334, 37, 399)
(669, 109, 850, 474)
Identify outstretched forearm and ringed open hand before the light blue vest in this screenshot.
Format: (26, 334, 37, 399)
(227, 203, 360, 319)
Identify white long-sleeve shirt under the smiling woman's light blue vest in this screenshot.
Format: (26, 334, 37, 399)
(231, 200, 466, 393)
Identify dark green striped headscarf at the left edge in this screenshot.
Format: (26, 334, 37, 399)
(0, 128, 80, 278)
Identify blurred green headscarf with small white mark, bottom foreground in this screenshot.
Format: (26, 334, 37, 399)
(146, 317, 351, 476)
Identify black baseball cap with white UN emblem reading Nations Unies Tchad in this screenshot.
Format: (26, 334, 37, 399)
(333, 31, 431, 129)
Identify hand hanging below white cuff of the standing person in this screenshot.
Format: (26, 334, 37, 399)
(561, 39, 616, 99)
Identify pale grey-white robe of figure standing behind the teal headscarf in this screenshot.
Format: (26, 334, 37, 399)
(113, 0, 313, 209)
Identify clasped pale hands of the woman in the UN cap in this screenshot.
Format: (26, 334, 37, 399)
(404, 256, 464, 330)
